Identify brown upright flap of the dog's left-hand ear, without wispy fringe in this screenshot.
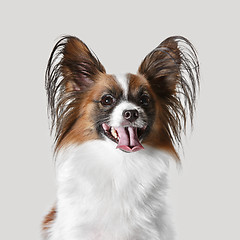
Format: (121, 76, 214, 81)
(59, 36, 105, 92)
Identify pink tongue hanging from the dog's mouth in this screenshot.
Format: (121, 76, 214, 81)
(115, 127, 144, 152)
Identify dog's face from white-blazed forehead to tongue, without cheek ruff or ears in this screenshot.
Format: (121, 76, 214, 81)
(90, 74, 156, 152)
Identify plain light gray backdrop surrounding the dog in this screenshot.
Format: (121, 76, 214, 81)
(0, 0, 240, 240)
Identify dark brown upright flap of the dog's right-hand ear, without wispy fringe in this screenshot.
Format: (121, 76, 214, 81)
(139, 37, 181, 97)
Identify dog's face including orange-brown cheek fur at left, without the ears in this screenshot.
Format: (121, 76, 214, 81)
(53, 73, 156, 152)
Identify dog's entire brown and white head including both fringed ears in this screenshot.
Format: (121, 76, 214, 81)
(46, 37, 198, 158)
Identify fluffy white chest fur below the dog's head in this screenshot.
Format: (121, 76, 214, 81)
(46, 140, 174, 240)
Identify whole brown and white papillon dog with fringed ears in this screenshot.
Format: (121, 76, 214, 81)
(43, 36, 199, 240)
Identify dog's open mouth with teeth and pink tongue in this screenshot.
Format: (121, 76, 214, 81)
(102, 123, 147, 153)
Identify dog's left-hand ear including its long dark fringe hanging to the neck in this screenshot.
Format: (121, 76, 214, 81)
(45, 36, 105, 146)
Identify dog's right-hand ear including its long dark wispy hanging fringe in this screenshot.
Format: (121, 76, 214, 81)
(139, 36, 199, 152)
